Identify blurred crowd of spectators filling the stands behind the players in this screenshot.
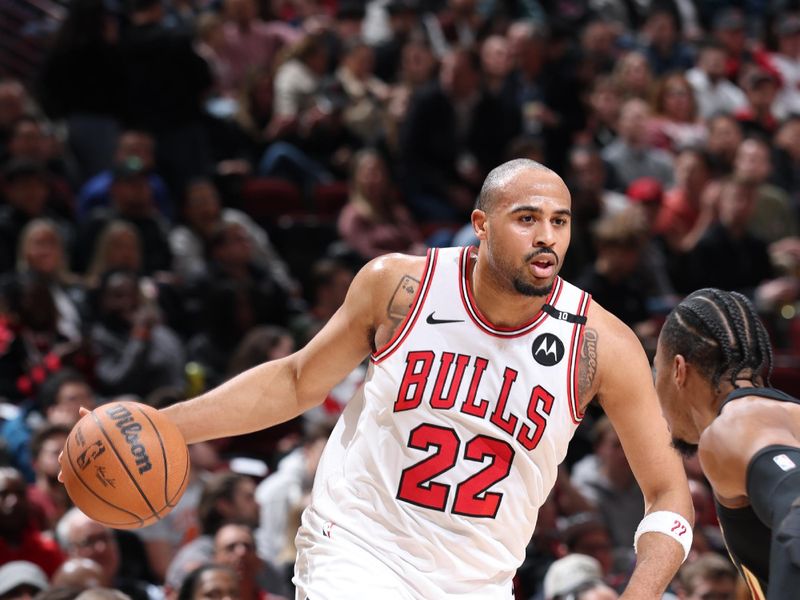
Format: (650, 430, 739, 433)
(0, 0, 800, 600)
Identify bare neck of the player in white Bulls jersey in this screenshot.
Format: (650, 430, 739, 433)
(467, 259, 547, 328)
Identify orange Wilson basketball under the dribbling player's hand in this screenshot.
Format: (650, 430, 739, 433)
(61, 402, 189, 529)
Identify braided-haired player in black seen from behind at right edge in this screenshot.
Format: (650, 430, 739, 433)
(655, 289, 800, 600)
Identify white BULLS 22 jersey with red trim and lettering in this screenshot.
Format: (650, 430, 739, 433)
(295, 248, 590, 600)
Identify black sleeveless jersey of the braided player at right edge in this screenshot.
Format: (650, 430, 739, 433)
(716, 388, 800, 600)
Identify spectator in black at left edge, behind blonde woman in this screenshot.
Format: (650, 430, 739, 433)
(0, 160, 72, 273)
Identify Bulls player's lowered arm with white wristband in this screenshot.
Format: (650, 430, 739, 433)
(584, 304, 694, 598)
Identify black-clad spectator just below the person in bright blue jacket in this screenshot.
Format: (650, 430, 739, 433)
(75, 158, 172, 275)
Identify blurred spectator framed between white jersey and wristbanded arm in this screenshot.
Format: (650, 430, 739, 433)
(570, 417, 644, 548)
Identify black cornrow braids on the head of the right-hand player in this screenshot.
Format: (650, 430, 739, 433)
(661, 288, 772, 389)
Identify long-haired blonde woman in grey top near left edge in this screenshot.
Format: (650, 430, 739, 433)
(17, 219, 86, 341)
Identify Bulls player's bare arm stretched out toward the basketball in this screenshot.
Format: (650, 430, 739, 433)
(162, 254, 425, 444)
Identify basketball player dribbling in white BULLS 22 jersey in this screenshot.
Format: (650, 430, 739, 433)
(134, 160, 692, 600)
